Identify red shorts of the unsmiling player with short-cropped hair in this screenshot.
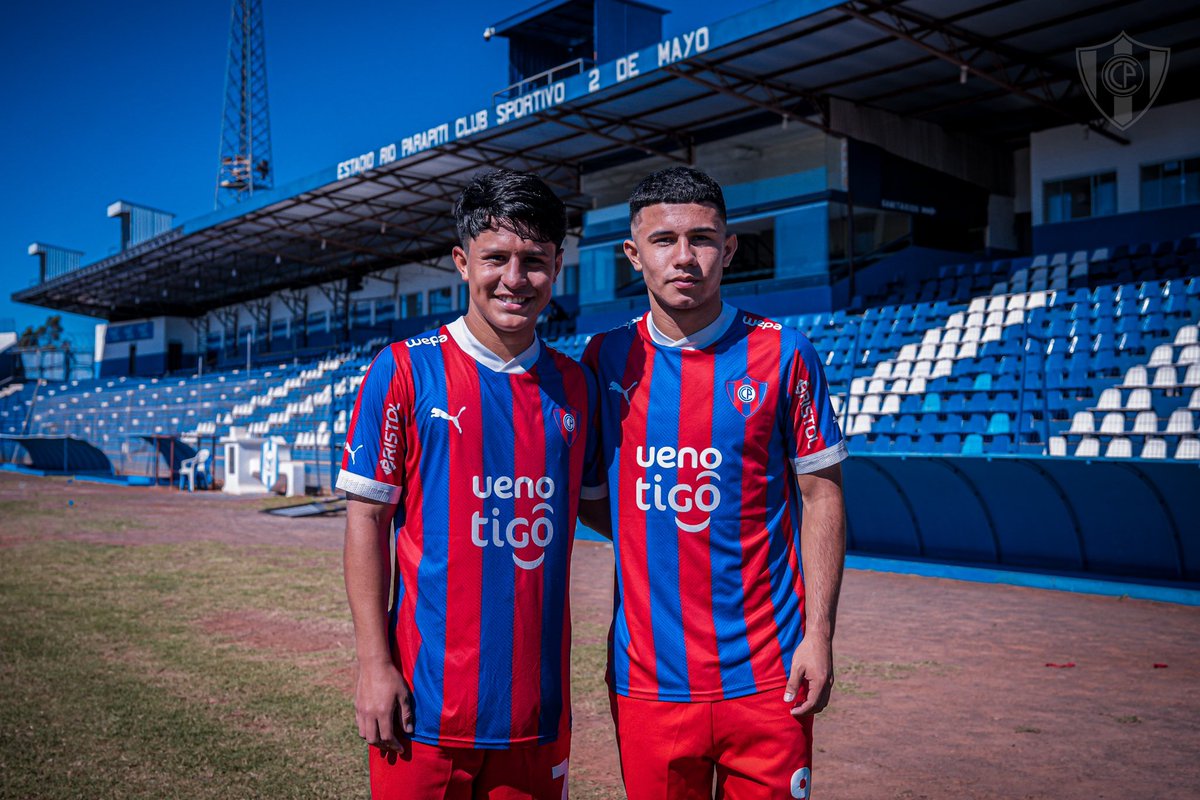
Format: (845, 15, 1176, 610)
(610, 688, 812, 800)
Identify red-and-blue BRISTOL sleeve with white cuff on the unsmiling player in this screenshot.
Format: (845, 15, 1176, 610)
(786, 336, 848, 475)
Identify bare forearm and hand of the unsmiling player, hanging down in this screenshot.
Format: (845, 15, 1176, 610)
(784, 463, 846, 716)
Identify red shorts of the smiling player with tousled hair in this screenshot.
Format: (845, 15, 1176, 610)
(370, 733, 571, 800)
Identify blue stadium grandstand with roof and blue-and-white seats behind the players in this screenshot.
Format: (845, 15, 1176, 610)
(0, 0, 1200, 583)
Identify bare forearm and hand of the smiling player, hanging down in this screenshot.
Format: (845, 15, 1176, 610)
(342, 494, 413, 750)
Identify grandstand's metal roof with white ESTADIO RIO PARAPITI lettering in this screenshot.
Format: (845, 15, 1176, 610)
(13, 0, 1200, 321)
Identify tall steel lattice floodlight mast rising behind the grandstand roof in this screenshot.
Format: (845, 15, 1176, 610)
(214, 0, 275, 209)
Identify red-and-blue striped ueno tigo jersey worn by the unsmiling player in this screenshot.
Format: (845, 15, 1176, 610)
(583, 305, 846, 702)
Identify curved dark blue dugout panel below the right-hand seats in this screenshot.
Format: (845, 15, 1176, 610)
(844, 455, 1200, 584)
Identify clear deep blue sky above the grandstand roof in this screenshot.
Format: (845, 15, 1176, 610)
(0, 0, 762, 349)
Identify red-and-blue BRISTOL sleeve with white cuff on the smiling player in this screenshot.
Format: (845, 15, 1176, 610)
(337, 347, 413, 505)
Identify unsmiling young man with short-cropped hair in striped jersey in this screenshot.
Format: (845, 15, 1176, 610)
(584, 167, 846, 800)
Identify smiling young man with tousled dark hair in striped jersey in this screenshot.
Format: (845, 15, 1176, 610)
(337, 165, 595, 800)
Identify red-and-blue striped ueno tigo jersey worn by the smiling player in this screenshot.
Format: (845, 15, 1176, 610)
(337, 318, 596, 748)
